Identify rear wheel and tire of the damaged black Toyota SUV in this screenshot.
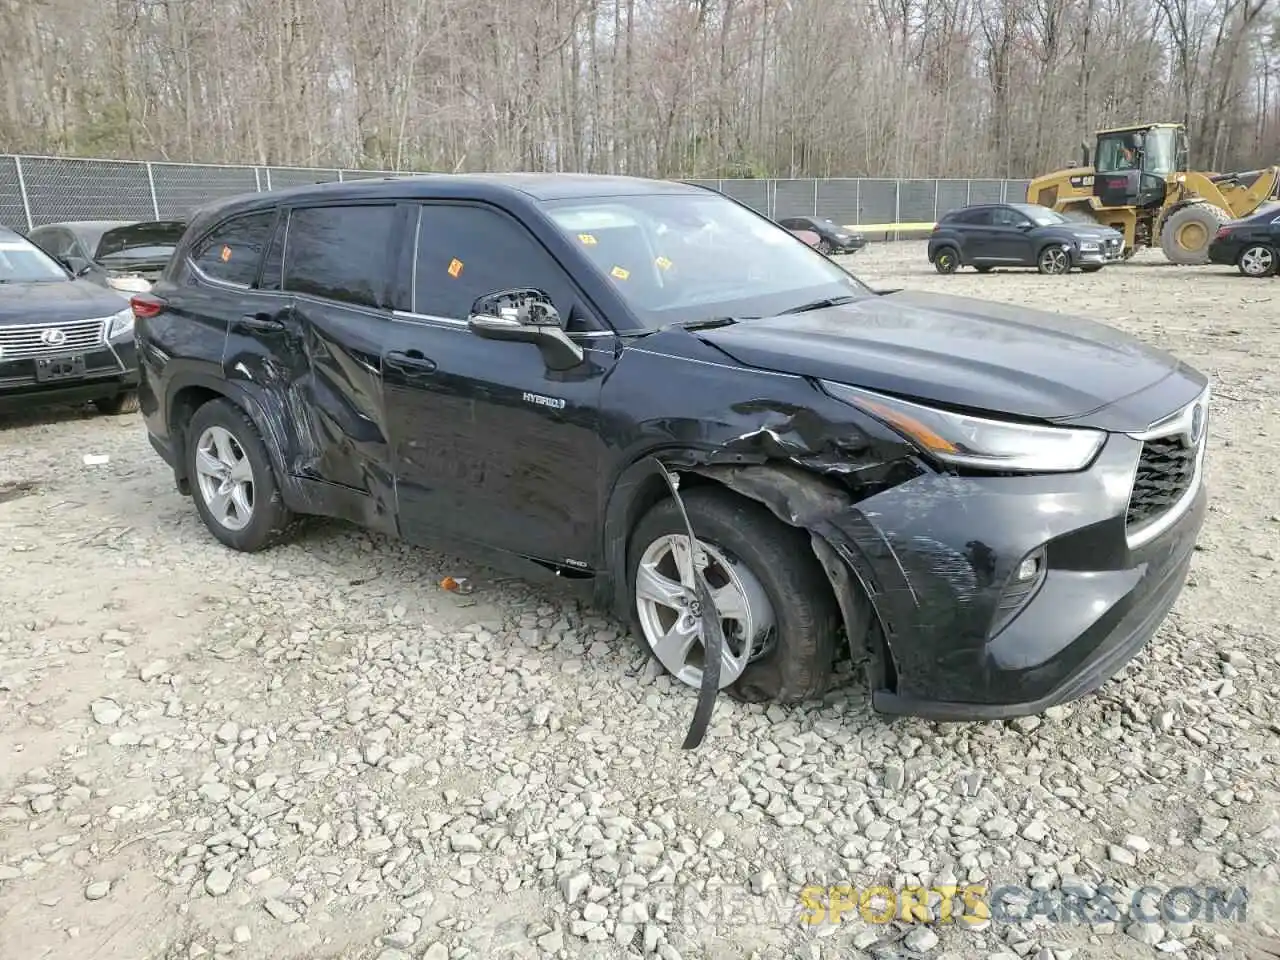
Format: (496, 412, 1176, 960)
(186, 399, 294, 553)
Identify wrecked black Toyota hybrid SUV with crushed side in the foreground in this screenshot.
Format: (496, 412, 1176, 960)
(133, 174, 1208, 718)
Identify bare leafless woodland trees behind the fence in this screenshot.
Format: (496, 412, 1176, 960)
(0, 0, 1280, 178)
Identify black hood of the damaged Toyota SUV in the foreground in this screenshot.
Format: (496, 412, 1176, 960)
(698, 291, 1204, 430)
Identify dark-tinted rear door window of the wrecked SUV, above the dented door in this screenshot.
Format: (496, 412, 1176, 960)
(284, 204, 397, 307)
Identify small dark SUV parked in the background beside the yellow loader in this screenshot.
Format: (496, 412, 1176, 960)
(929, 204, 1124, 274)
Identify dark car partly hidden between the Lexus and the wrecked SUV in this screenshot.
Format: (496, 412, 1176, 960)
(27, 220, 187, 294)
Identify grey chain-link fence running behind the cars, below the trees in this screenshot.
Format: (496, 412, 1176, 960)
(0, 155, 1027, 237)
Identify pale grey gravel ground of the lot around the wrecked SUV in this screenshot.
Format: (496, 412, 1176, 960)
(0, 243, 1280, 960)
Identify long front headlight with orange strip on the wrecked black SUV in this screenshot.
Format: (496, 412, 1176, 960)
(822, 380, 1106, 474)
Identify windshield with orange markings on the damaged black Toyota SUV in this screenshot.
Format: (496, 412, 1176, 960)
(547, 193, 873, 328)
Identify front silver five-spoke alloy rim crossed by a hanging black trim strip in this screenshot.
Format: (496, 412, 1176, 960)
(635, 534, 774, 687)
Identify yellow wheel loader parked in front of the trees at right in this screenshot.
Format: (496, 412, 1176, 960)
(1027, 123, 1280, 265)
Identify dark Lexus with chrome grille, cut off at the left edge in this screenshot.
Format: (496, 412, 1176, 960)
(0, 227, 138, 413)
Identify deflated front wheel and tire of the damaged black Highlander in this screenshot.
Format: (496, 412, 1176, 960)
(627, 488, 841, 703)
